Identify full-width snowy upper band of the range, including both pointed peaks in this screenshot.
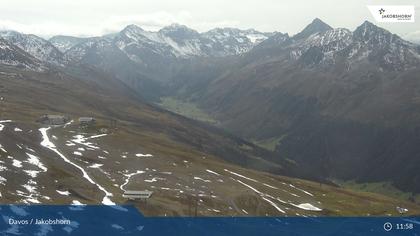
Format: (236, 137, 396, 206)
(0, 21, 419, 73)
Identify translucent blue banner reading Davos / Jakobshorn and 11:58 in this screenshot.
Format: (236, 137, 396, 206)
(0, 205, 420, 236)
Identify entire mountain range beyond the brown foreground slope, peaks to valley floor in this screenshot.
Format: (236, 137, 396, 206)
(0, 19, 420, 195)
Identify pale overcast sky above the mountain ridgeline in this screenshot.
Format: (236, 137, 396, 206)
(0, 0, 420, 40)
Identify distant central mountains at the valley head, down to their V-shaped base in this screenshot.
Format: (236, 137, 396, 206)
(46, 24, 271, 101)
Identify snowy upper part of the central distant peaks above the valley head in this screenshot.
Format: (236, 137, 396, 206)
(63, 24, 271, 62)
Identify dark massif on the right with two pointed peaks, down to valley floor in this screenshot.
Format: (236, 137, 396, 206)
(167, 19, 420, 192)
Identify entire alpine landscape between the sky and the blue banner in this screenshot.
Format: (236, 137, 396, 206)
(0, 19, 420, 216)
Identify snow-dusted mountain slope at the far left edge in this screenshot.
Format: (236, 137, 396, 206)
(0, 31, 65, 65)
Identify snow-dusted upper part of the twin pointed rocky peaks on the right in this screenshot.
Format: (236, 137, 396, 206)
(253, 19, 420, 70)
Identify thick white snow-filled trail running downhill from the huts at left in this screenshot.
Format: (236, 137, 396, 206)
(39, 127, 115, 205)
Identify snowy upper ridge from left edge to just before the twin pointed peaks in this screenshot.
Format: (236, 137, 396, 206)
(0, 24, 273, 74)
